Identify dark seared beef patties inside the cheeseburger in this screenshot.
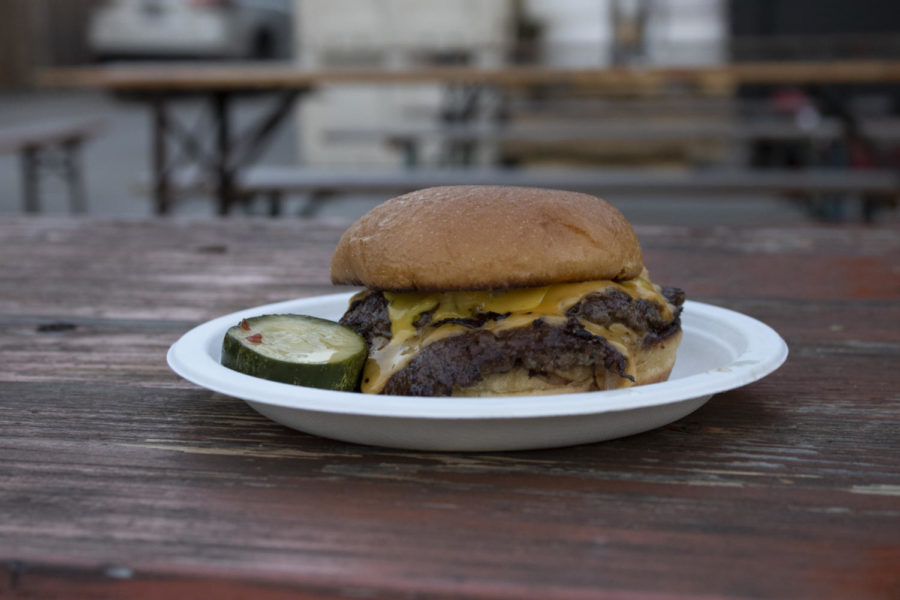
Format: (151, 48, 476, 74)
(341, 287, 684, 396)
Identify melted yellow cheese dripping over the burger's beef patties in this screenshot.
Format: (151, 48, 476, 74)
(351, 270, 673, 394)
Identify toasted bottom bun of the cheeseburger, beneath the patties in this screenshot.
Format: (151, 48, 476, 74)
(452, 330, 682, 396)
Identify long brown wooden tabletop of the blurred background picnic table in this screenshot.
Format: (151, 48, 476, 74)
(36, 60, 900, 92)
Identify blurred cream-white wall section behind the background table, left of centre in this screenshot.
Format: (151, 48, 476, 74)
(294, 0, 515, 165)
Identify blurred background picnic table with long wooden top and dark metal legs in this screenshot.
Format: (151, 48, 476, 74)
(36, 60, 900, 214)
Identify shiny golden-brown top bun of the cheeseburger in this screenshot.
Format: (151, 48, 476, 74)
(331, 186, 643, 291)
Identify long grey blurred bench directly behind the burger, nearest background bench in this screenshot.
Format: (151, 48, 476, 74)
(153, 166, 900, 220)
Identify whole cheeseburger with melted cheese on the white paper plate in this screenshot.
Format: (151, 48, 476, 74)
(331, 186, 684, 396)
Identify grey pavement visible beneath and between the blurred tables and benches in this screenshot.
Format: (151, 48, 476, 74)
(0, 92, 884, 225)
